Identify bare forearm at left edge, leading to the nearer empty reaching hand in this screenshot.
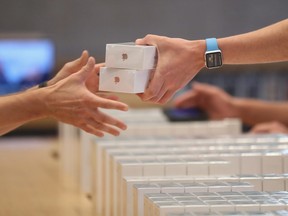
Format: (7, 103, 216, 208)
(0, 89, 45, 135)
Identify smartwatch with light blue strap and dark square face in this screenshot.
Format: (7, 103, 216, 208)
(205, 38, 222, 69)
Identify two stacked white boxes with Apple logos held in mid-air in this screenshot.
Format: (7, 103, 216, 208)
(99, 43, 157, 93)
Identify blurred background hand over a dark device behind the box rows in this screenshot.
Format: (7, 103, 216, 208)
(173, 82, 237, 119)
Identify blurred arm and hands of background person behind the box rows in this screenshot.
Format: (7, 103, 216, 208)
(173, 82, 288, 134)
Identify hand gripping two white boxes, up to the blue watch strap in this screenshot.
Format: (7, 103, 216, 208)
(136, 35, 205, 104)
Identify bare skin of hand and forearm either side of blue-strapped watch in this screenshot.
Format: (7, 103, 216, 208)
(136, 19, 288, 104)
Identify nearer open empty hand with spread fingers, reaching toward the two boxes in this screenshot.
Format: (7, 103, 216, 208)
(43, 57, 128, 137)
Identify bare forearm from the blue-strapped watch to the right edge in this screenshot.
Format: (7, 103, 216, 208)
(218, 19, 288, 64)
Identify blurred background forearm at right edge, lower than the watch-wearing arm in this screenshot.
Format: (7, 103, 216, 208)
(233, 98, 288, 126)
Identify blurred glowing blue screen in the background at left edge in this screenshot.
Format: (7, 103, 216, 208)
(0, 37, 55, 95)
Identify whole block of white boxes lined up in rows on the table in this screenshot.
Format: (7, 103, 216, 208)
(62, 109, 288, 216)
